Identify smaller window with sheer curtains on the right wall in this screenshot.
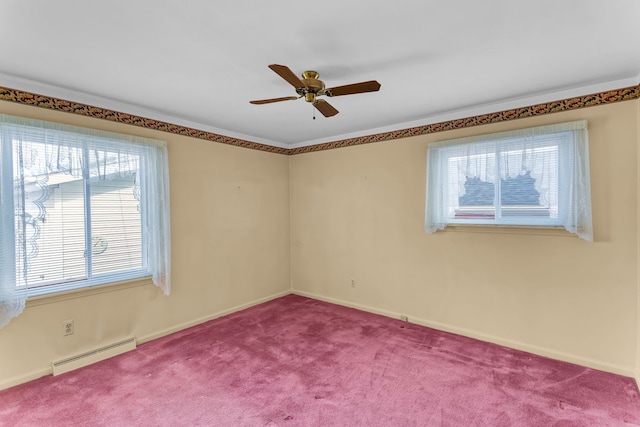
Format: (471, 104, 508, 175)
(425, 121, 593, 241)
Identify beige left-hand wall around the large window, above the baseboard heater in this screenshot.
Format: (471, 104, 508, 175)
(0, 102, 291, 389)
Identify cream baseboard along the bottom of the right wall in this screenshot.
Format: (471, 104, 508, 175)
(291, 289, 640, 378)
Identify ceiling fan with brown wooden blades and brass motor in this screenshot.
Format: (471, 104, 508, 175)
(249, 64, 380, 118)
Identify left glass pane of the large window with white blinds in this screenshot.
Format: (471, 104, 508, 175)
(14, 143, 87, 287)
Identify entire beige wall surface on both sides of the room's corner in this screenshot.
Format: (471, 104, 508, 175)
(0, 95, 640, 389)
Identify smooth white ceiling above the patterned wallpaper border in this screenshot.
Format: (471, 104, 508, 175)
(0, 0, 640, 148)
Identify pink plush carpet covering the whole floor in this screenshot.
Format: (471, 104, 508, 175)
(0, 295, 640, 427)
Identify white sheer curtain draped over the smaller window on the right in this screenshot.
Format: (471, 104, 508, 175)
(425, 120, 593, 241)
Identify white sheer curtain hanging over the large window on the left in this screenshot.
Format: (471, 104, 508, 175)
(0, 115, 171, 328)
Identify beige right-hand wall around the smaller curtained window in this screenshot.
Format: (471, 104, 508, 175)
(291, 101, 640, 376)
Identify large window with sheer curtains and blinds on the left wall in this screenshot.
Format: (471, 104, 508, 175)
(0, 115, 170, 327)
